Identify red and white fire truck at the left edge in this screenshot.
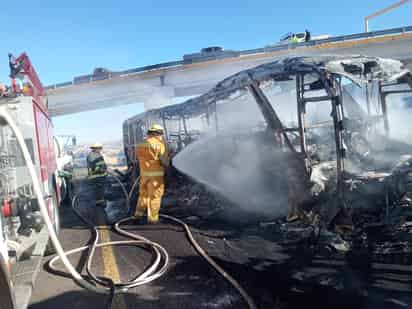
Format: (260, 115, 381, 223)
(0, 53, 60, 309)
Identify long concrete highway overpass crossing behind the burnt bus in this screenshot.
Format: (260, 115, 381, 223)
(47, 26, 412, 116)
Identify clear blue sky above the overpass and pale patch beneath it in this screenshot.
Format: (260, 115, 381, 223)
(0, 0, 412, 143)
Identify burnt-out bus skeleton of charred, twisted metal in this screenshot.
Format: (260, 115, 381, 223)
(123, 56, 412, 265)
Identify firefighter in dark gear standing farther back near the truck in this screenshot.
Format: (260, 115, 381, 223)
(87, 143, 107, 206)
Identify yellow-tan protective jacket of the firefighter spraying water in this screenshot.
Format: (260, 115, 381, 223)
(136, 136, 169, 176)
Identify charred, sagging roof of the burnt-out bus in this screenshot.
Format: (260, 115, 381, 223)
(124, 56, 410, 120)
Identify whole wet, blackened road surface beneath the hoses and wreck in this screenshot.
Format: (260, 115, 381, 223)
(30, 176, 412, 309)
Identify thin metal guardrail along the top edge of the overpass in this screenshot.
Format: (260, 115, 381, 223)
(46, 26, 412, 90)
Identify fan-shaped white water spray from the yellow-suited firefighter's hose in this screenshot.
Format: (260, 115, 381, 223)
(174, 132, 287, 215)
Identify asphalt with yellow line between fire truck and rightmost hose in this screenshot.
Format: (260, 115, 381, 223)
(30, 178, 244, 309)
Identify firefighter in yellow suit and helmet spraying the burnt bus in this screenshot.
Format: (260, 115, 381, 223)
(135, 124, 170, 223)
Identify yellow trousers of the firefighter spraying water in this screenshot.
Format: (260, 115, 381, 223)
(135, 176, 165, 223)
